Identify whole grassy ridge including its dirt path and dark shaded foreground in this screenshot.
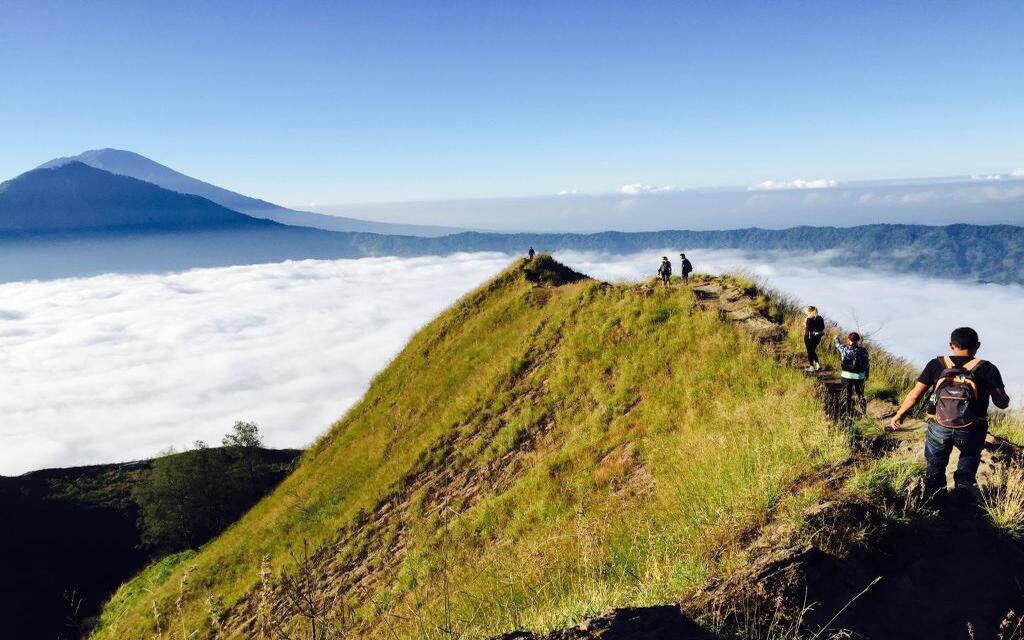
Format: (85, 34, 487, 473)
(61, 255, 1024, 640)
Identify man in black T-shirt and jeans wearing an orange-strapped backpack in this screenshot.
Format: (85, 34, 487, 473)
(890, 327, 1010, 498)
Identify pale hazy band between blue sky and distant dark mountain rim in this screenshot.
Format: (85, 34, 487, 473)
(306, 175, 1024, 232)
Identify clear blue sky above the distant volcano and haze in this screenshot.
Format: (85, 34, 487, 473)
(0, 1, 1024, 205)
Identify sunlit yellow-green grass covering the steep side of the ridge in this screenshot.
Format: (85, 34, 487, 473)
(94, 258, 849, 639)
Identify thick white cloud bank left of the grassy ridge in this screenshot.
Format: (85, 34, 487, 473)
(0, 254, 509, 475)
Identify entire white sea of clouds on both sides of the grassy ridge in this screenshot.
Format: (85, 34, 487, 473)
(0, 251, 1024, 475)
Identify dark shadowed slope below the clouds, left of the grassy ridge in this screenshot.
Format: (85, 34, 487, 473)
(0, 449, 301, 640)
